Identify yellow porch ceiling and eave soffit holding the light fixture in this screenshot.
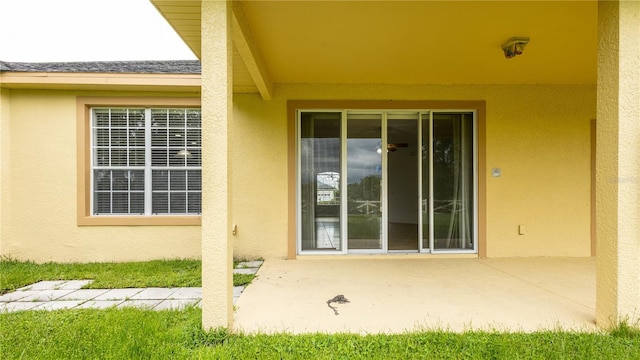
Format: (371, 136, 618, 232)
(153, 0, 598, 91)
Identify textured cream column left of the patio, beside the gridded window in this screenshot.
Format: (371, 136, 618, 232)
(201, 0, 233, 329)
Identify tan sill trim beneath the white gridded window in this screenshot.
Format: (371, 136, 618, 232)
(78, 215, 202, 226)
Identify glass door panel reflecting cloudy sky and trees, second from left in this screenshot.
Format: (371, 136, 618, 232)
(347, 114, 383, 250)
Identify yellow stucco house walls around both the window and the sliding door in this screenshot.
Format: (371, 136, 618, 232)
(0, 84, 596, 261)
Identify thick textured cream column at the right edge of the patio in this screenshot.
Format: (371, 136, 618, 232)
(596, 1, 640, 328)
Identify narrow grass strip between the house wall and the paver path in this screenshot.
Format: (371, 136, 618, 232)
(0, 258, 255, 295)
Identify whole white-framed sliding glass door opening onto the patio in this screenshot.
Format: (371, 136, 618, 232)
(297, 110, 477, 254)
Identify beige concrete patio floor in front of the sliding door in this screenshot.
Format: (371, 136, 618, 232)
(234, 256, 597, 333)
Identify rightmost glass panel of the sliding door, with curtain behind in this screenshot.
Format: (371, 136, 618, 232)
(432, 112, 474, 250)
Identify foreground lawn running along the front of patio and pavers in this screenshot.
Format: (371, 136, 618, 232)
(0, 308, 640, 359)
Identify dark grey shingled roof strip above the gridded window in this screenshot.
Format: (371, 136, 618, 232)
(0, 60, 201, 74)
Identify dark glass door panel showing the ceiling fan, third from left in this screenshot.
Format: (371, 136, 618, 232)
(386, 113, 420, 251)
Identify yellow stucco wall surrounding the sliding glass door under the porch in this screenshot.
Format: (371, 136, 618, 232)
(230, 84, 596, 258)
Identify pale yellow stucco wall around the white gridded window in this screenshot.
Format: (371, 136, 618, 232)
(0, 89, 201, 262)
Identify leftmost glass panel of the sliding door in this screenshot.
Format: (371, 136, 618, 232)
(299, 112, 344, 251)
